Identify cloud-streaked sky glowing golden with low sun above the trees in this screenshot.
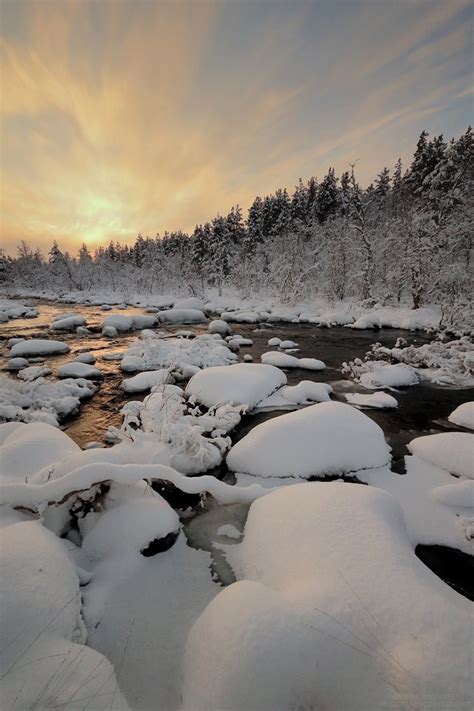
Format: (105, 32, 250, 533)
(0, 0, 473, 254)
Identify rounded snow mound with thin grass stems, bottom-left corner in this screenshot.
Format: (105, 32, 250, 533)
(0, 510, 128, 711)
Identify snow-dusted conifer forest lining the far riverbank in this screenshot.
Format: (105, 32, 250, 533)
(4, 127, 474, 310)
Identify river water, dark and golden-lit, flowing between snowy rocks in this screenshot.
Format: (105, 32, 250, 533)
(0, 300, 474, 594)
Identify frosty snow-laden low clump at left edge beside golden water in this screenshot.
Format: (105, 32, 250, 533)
(0, 377, 96, 427)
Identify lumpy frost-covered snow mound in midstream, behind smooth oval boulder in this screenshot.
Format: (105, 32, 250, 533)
(122, 334, 237, 377)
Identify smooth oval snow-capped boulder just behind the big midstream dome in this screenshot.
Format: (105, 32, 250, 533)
(186, 363, 286, 409)
